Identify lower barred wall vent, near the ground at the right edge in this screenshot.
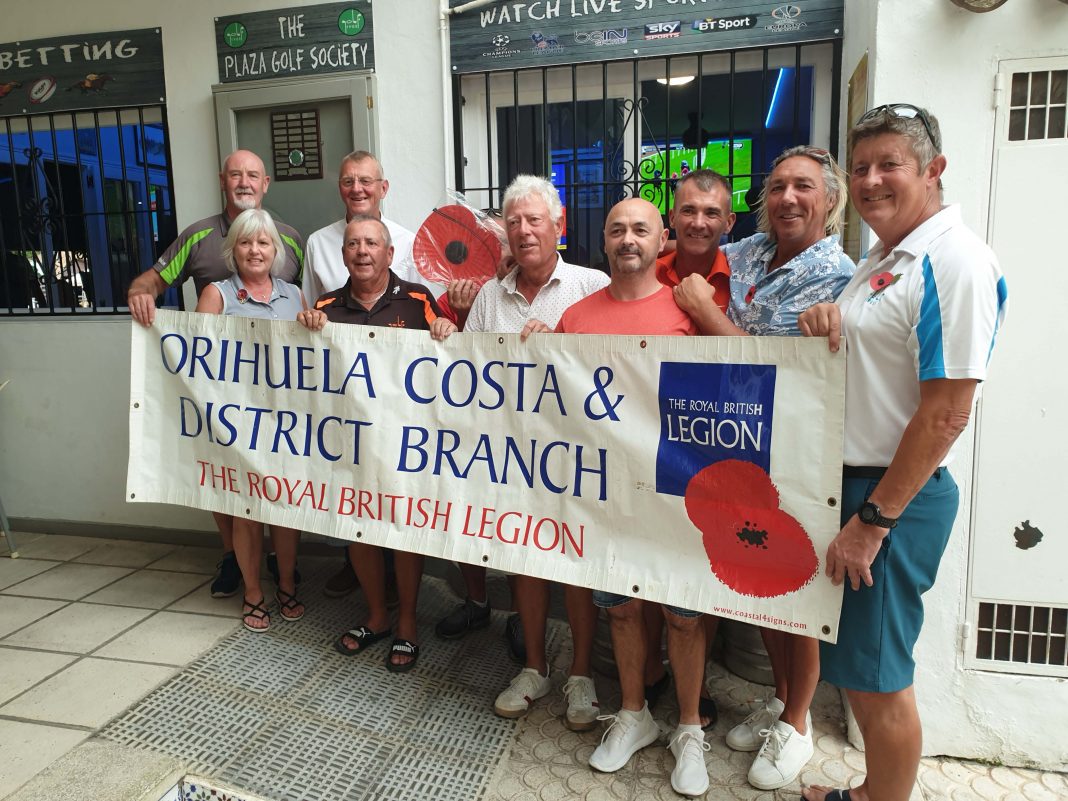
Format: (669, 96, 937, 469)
(974, 602, 1068, 676)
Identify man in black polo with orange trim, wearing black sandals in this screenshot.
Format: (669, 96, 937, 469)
(297, 215, 456, 673)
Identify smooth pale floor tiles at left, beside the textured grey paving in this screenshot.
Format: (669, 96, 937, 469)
(0, 534, 240, 798)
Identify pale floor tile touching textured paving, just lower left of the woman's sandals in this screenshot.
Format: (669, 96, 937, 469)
(94, 612, 241, 665)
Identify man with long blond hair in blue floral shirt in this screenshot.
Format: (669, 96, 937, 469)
(675, 146, 855, 790)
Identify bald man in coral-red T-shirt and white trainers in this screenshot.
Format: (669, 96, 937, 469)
(556, 198, 708, 796)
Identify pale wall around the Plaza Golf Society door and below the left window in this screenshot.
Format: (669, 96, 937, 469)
(0, 0, 451, 530)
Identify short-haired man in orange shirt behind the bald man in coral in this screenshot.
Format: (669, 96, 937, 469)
(657, 170, 735, 312)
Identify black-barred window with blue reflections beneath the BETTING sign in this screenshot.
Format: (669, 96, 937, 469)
(0, 106, 180, 317)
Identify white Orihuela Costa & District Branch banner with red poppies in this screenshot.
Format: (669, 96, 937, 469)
(127, 311, 845, 642)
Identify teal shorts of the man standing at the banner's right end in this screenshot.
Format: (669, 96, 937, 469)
(819, 468, 960, 692)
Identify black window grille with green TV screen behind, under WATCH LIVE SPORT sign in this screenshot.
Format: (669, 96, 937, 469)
(453, 41, 842, 269)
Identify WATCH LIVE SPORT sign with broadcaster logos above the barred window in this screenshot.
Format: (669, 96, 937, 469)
(449, 0, 845, 74)
